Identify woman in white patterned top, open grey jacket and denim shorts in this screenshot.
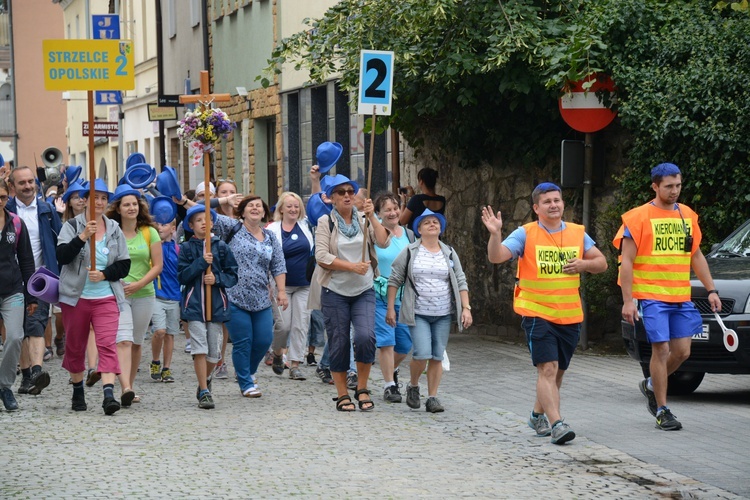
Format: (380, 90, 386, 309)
(385, 209, 471, 413)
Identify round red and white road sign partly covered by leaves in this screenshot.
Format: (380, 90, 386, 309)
(558, 73, 617, 133)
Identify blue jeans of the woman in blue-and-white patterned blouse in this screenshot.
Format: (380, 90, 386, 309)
(231, 304, 273, 392)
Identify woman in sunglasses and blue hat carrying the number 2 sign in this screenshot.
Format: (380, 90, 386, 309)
(309, 174, 389, 411)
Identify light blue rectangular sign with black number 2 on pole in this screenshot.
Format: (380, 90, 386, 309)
(357, 50, 394, 116)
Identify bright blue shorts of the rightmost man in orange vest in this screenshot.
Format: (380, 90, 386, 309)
(638, 300, 703, 344)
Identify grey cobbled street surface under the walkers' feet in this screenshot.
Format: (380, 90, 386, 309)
(0, 335, 750, 498)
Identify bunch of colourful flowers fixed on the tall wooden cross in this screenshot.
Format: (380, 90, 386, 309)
(177, 106, 235, 167)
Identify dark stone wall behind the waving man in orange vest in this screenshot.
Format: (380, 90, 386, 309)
(402, 126, 632, 340)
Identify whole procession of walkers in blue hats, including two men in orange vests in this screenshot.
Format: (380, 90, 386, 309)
(0, 150, 721, 444)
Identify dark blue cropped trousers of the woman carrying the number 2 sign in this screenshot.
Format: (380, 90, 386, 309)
(321, 288, 375, 373)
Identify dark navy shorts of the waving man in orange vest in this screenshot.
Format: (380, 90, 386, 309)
(521, 316, 581, 370)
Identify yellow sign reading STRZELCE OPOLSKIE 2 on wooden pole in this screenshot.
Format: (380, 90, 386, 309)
(42, 40, 135, 90)
